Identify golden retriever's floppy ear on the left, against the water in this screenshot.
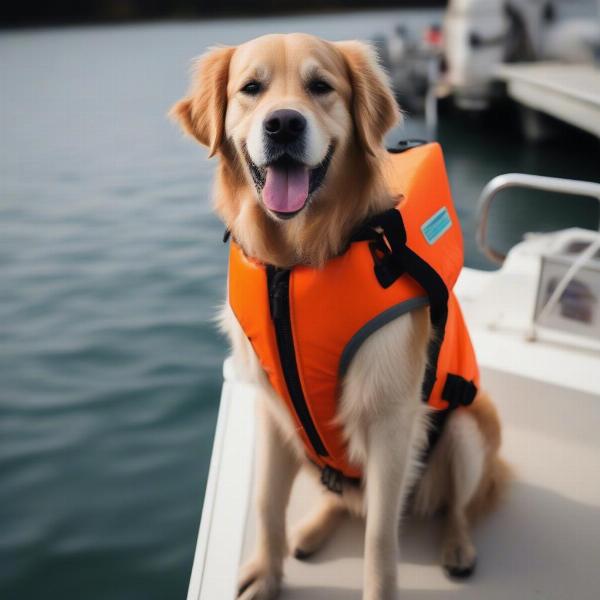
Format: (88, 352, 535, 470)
(169, 46, 234, 157)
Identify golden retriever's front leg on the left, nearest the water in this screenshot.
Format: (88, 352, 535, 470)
(238, 399, 300, 600)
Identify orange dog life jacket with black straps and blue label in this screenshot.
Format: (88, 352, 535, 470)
(228, 144, 479, 491)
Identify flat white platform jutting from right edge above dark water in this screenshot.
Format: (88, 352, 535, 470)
(496, 62, 600, 137)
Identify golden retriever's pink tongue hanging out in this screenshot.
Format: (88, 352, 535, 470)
(263, 165, 308, 212)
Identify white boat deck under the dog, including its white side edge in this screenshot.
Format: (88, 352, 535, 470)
(188, 269, 600, 600)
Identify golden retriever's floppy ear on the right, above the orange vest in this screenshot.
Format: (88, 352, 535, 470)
(335, 41, 401, 156)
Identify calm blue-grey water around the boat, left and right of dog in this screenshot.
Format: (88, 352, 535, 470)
(0, 13, 599, 600)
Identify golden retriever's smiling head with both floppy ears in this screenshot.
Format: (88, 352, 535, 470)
(171, 34, 399, 262)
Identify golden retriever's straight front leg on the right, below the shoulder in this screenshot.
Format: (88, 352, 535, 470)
(363, 407, 420, 600)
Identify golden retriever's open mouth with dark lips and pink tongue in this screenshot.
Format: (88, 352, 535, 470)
(245, 144, 334, 219)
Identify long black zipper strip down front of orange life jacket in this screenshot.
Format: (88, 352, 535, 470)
(267, 267, 328, 456)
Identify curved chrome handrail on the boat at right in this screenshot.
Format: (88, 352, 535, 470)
(477, 173, 600, 264)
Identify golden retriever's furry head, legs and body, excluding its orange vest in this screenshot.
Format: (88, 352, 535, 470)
(171, 34, 508, 600)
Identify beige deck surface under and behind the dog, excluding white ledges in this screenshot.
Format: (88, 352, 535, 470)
(242, 369, 600, 600)
